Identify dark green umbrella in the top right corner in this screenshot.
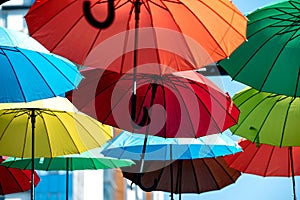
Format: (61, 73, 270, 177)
(219, 0, 300, 96)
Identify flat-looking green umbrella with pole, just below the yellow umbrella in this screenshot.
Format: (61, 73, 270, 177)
(1, 148, 134, 199)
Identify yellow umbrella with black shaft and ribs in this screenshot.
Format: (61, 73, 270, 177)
(0, 97, 112, 199)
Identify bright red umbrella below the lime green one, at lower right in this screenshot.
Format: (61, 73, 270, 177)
(224, 140, 300, 199)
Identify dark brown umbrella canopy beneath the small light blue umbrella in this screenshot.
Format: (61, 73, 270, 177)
(122, 157, 241, 194)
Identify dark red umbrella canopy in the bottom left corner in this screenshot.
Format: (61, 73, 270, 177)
(0, 158, 40, 195)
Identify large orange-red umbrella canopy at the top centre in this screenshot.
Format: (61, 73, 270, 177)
(25, 0, 247, 73)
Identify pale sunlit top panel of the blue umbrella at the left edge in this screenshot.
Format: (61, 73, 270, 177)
(0, 26, 49, 53)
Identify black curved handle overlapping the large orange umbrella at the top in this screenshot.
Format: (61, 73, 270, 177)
(83, 0, 115, 28)
